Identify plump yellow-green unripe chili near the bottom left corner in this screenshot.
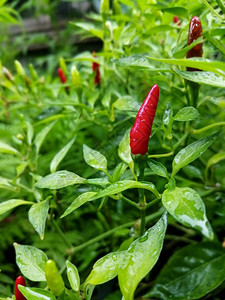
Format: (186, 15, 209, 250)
(45, 259, 65, 296)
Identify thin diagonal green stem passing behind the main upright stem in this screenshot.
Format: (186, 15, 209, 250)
(70, 208, 165, 255)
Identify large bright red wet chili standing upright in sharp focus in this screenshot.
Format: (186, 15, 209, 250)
(130, 84, 159, 155)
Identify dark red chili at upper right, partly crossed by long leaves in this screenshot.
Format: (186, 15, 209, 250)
(186, 16, 203, 71)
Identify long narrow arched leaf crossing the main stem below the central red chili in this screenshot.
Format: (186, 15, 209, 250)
(92, 180, 160, 200)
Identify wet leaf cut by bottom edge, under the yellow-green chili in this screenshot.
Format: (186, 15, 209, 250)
(19, 285, 56, 300)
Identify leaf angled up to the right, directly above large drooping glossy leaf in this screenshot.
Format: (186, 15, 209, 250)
(172, 135, 216, 176)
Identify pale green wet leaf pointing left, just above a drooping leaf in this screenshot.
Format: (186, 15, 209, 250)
(35, 170, 85, 190)
